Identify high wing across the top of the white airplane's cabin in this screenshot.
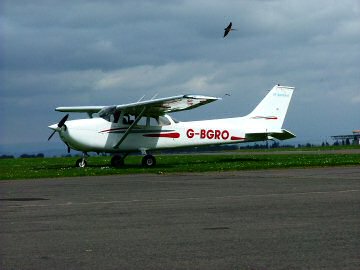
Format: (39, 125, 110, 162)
(55, 95, 220, 117)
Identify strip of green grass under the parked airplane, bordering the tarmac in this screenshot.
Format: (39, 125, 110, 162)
(0, 152, 360, 180)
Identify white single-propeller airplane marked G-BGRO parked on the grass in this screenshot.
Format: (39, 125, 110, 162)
(49, 85, 295, 167)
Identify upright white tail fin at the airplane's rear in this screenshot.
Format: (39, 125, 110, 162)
(246, 85, 295, 132)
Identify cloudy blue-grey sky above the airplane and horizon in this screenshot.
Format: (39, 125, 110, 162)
(0, 0, 360, 153)
